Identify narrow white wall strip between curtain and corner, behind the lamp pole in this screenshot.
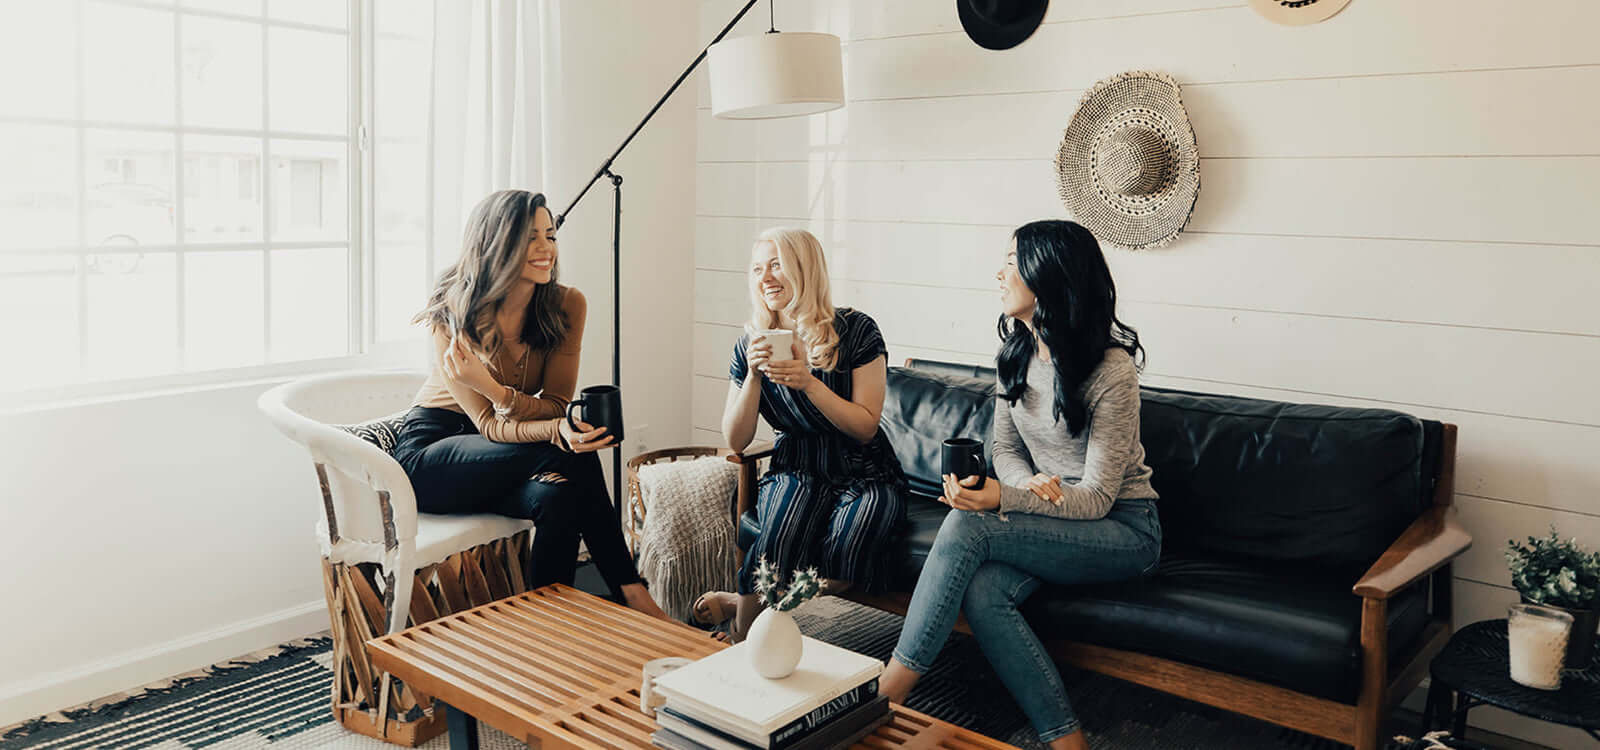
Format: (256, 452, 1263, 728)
(544, 0, 707, 460)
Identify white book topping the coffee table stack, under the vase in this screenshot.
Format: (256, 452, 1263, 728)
(656, 638, 883, 735)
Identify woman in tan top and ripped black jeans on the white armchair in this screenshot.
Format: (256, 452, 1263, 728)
(395, 190, 666, 617)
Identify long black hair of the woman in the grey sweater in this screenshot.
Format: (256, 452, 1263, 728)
(995, 219, 1144, 435)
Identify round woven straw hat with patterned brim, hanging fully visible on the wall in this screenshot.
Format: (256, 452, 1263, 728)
(1056, 70, 1200, 249)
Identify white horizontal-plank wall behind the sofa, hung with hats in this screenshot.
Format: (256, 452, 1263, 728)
(693, 0, 1600, 747)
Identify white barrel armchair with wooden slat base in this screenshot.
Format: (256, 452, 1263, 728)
(258, 373, 533, 747)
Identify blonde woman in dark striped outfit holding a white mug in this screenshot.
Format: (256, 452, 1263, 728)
(694, 229, 906, 640)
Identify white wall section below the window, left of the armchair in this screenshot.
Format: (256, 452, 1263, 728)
(0, 384, 344, 724)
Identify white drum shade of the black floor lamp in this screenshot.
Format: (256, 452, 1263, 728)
(707, 32, 845, 120)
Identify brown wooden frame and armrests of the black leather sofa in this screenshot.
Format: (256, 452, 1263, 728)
(728, 364, 1472, 750)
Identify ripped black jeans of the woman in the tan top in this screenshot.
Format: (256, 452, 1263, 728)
(395, 406, 642, 593)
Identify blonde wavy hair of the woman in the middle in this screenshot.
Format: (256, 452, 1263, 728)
(747, 227, 838, 371)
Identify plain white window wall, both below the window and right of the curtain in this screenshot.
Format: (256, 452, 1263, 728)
(0, 0, 699, 726)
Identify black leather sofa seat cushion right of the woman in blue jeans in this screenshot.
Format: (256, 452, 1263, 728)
(1022, 557, 1427, 704)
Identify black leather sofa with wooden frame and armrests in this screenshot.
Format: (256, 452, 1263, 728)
(731, 360, 1470, 750)
